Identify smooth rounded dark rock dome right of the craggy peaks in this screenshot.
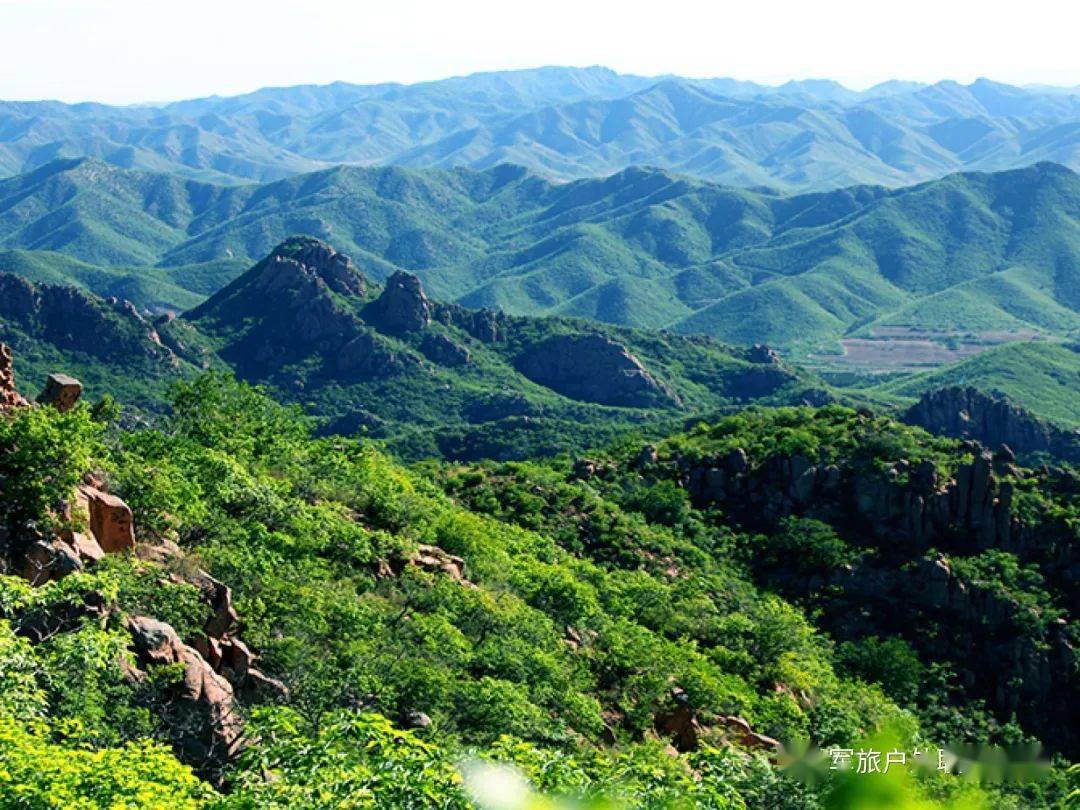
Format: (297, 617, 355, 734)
(515, 335, 678, 407)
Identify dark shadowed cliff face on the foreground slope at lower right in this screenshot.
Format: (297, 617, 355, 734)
(673, 434, 1080, 760)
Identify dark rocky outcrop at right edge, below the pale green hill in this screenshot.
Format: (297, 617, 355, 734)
(904, 387, 1080, 463)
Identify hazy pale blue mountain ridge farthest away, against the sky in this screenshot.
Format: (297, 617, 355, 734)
(0, 67, 1080, 190)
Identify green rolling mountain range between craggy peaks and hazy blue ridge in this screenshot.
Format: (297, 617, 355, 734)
(0, 159, 1080, 352)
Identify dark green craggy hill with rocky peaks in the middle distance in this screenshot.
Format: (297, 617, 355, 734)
(0, 238, 828, 458)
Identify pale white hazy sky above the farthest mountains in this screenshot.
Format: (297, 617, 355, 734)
(0, 0, 1080, 103)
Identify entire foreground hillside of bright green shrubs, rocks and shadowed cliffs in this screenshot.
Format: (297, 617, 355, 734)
(0, 376, 1077, 810)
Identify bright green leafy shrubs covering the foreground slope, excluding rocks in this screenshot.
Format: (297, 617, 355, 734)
(0, 375, 1077, 809)
